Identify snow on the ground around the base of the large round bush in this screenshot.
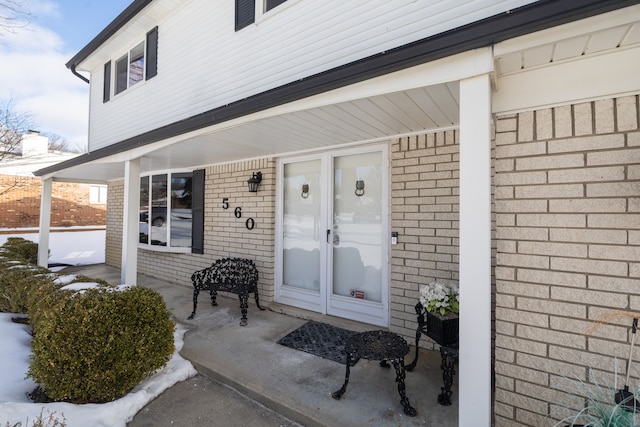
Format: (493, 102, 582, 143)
(0, 313, 196, 427)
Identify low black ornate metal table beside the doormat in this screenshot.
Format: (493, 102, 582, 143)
(331, 331, 417, 417)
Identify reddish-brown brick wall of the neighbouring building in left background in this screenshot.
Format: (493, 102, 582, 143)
(0, 175, 106, 228)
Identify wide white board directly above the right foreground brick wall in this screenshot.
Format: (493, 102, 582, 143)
(492, 47, 640, 114)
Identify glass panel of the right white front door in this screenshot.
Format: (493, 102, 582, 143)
(333, 152, 382, 302)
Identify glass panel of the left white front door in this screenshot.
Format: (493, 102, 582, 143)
(282, 160, 325, 293)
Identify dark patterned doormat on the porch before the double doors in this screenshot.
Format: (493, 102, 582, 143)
(278, 321, 358, 366)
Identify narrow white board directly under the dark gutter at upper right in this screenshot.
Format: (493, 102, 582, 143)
(493, 5, 640, 57)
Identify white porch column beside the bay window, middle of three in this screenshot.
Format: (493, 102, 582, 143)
(120, 159, 140, 285)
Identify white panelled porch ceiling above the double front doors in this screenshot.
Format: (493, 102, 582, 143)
(50, 82, 459, 181)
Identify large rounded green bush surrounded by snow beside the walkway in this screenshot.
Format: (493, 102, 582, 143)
(27, 286, 175, 404)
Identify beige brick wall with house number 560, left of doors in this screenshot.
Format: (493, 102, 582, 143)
(106, 159, 275, 302)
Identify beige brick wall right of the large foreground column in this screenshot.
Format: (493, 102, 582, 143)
(495, 96, 640, 426)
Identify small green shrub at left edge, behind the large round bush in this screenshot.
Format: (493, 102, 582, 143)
(0, 264, 53, 313)
